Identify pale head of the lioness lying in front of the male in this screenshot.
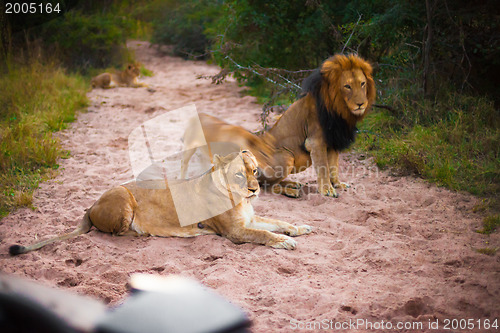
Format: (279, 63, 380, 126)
(214, 150, 260, 203)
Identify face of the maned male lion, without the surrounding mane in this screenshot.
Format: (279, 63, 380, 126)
(340, 69, 368, 117)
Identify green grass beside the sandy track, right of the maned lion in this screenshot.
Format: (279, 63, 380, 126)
(356, 89, 500, 197)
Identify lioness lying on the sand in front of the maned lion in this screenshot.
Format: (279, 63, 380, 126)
(9, 151, 312, 255)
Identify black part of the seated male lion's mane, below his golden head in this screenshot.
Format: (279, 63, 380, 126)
(300, 68, 357, 151)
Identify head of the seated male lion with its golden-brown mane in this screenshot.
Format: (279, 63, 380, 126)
(320, 54, 376, 124)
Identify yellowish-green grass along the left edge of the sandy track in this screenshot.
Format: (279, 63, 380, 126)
(0, 62, 88, 217)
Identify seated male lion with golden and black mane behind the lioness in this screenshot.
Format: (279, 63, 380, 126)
(183, 55, 376, 197)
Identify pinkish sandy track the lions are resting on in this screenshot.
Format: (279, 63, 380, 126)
(0, 43, 500, 332)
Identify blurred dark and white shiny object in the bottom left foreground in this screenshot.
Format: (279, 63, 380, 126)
(0, 274, 250, 333)
